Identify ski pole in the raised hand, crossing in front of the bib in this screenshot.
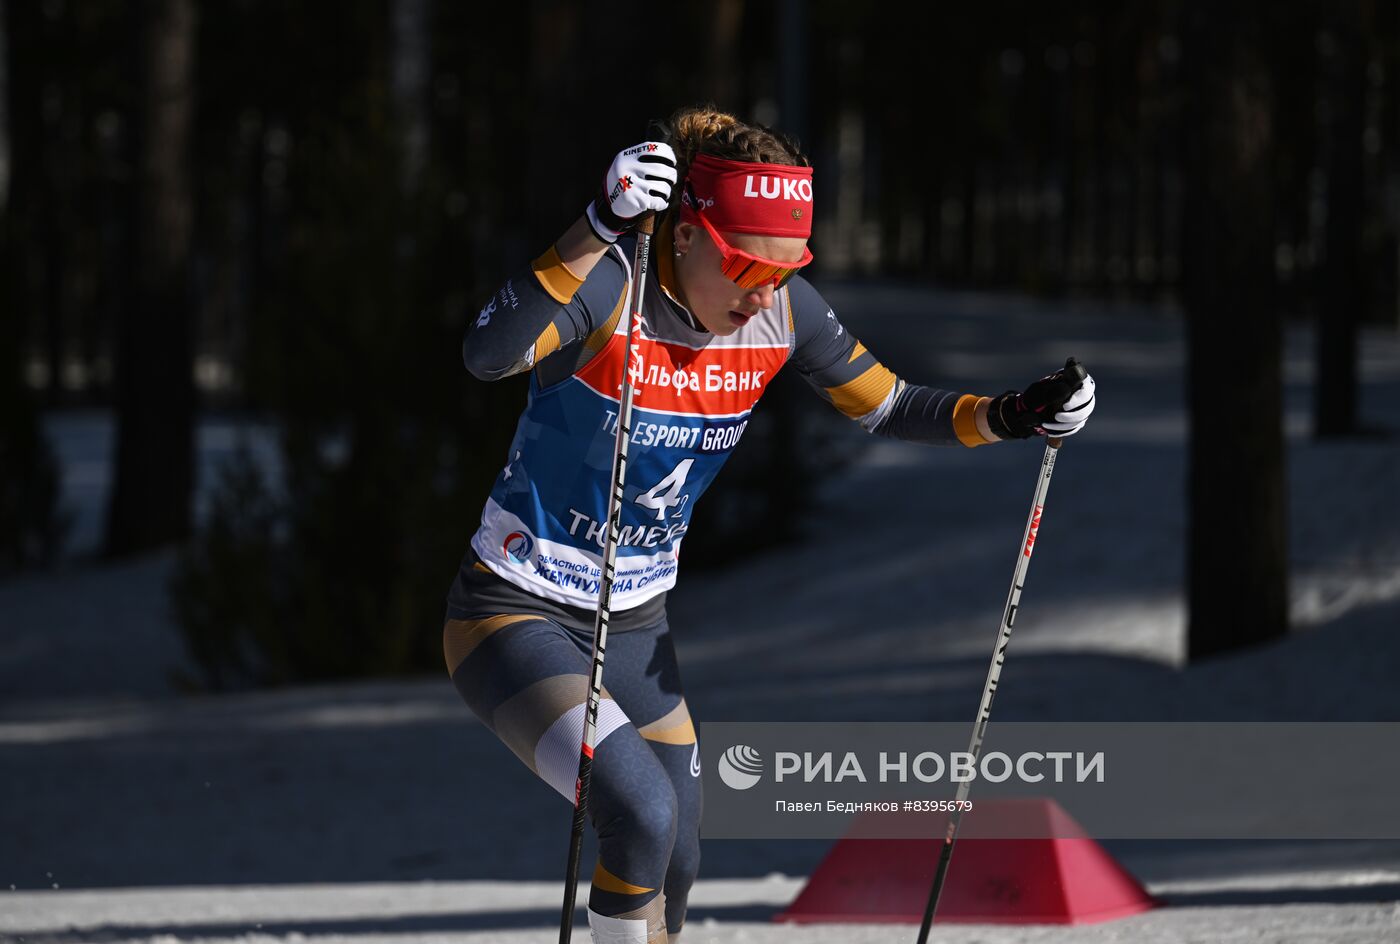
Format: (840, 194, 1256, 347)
(559, 216, 657, 944)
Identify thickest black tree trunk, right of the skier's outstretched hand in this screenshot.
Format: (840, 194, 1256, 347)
(1184, 0, 1288, 661)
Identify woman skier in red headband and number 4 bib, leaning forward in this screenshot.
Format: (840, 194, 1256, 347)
(442, 109, 1093, 944)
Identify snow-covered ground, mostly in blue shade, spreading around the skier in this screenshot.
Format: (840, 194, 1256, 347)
(0, 284, 1400, 944)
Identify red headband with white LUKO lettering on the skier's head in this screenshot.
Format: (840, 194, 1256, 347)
(680, 154, 812, 240)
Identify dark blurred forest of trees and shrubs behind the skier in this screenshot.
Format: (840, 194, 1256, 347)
(0, 0, 1400, 688)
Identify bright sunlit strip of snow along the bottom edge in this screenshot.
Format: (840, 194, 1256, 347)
(8, 875, 1400, 944)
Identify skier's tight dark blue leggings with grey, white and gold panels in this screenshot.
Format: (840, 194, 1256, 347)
(442, 606, 701, 943)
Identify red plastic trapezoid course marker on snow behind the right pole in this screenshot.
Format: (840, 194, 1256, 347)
(774, 800, 1156, 924)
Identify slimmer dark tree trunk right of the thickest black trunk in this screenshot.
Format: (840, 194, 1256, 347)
(1313, 0, 1366, 438)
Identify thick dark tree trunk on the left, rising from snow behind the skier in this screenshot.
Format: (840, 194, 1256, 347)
(106, 0, 195, 556)
